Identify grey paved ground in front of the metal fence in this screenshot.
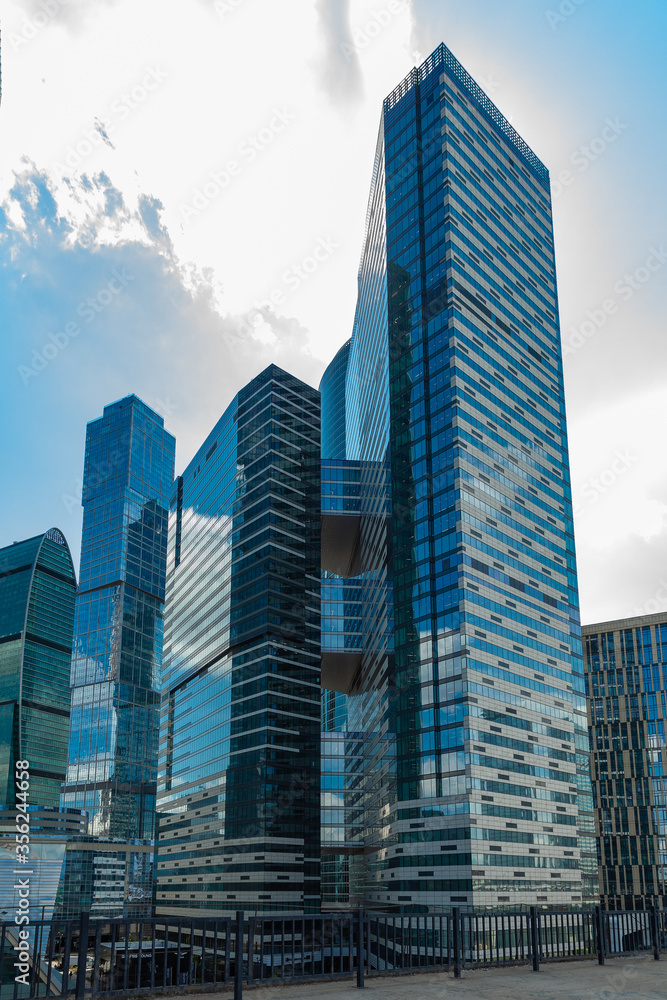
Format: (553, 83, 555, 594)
(180, 956, 667, 1000)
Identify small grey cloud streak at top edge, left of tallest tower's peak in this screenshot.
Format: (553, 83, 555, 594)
(315, 0, 363, 104)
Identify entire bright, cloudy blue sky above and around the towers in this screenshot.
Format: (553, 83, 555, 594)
(0, 0, 667, 622)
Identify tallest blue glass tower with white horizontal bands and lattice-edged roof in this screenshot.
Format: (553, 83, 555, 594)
(336, 45, 597, 909)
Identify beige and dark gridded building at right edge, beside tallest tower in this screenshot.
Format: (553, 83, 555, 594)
(582, 614, 667, 910)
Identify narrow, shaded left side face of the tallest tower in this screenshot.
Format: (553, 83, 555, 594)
(346, 111, 396, 906)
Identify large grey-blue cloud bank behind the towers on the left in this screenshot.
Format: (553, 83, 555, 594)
(0, 164, 322, 559)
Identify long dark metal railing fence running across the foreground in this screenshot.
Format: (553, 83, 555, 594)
(0, 907, 667, 1000)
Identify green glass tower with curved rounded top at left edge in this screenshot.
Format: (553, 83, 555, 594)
(0, 528, 76, 807)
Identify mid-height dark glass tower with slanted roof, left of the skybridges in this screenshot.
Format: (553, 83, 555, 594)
(156, 365, 320, 916)
